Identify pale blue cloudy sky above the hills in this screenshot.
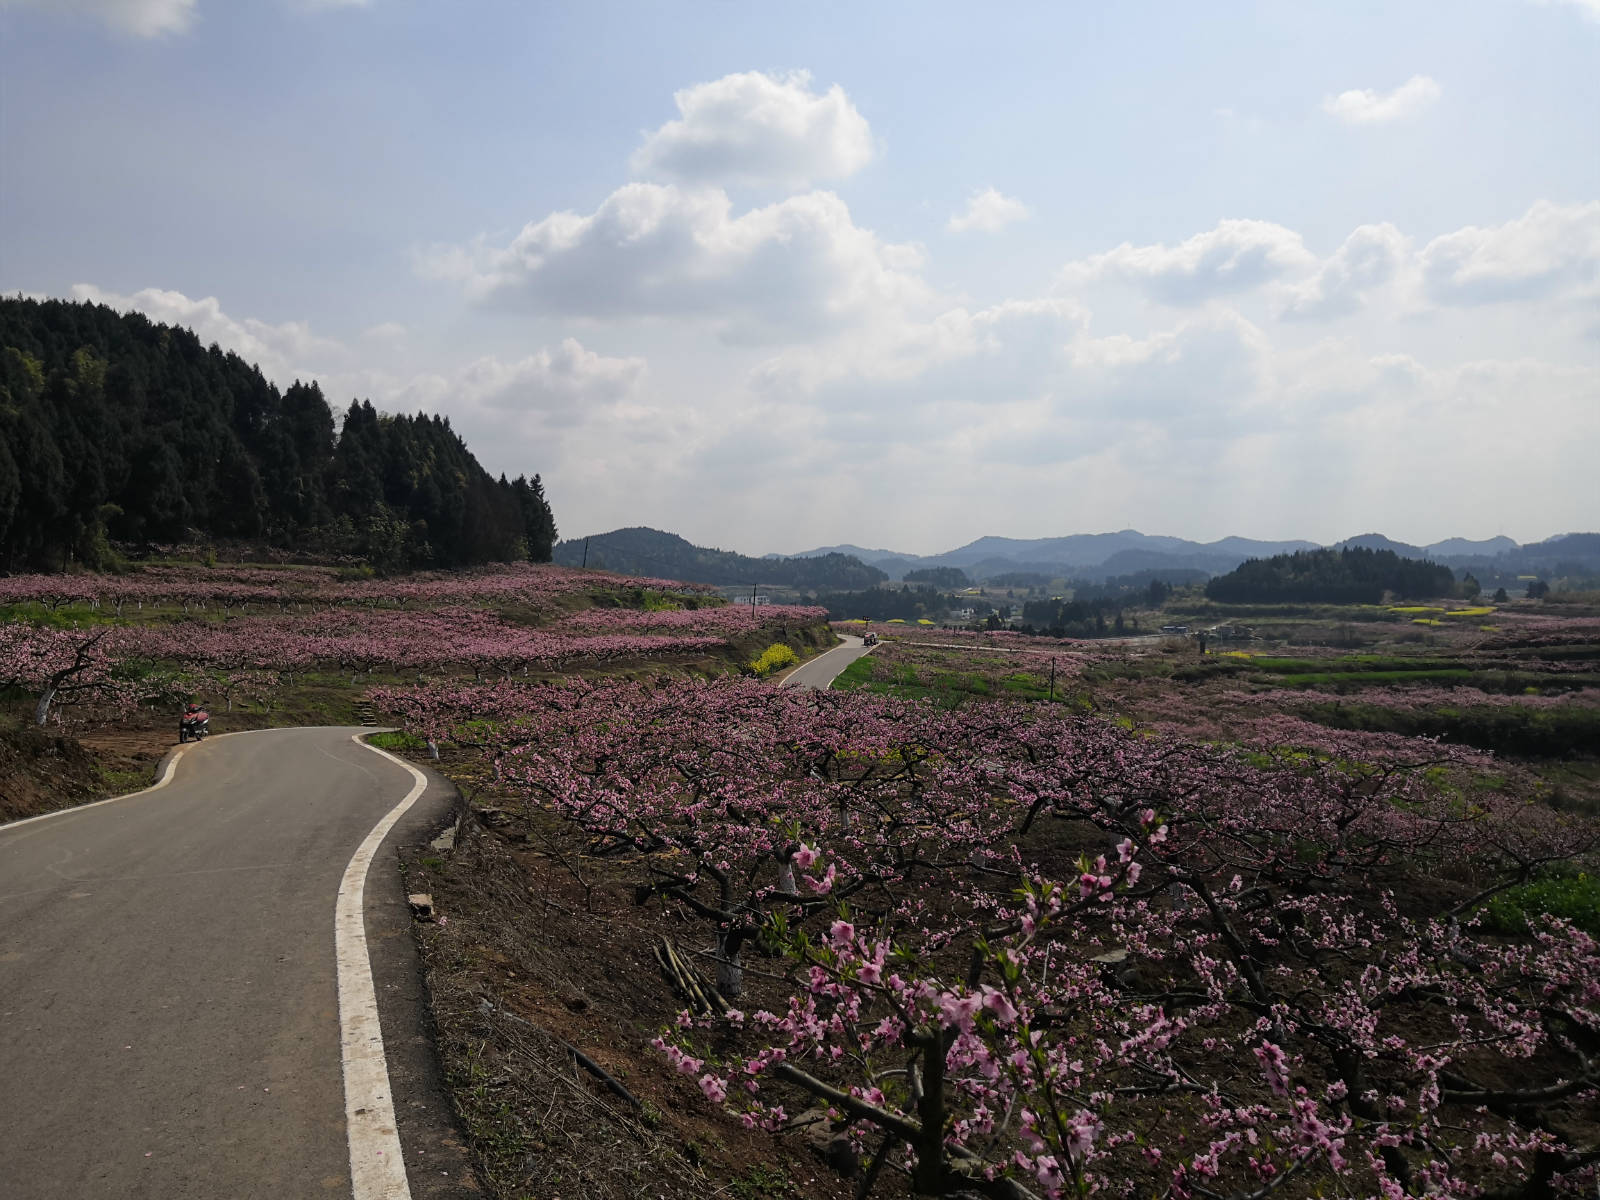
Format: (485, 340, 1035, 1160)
(0, 0, 1600, 554)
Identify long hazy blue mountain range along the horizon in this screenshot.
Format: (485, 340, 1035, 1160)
(554, 526, 1600, 592)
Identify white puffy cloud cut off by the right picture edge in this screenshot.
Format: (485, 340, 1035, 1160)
(1421, 200, 1600, 304)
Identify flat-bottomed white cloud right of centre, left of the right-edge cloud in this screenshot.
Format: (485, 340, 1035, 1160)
(1061, 219, 1317, 306)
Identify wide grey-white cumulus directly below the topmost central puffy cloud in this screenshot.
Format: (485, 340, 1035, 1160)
(419, 184, 930, 342)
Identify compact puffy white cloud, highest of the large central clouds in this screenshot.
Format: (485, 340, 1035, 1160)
(630, 70, 874, 189)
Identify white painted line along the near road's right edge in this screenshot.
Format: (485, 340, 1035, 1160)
(333, 730, 427, 1200)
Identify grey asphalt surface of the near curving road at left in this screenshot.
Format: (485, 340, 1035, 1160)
(0, 730, 470, 1200)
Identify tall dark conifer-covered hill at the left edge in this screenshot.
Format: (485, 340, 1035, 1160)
(0, 298, 555, 570)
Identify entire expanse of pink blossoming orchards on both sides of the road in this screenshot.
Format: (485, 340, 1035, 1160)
(0, 566, 1600, 1200)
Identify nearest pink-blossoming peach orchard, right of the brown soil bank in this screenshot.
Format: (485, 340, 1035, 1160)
(379, 680, 1600, 1200)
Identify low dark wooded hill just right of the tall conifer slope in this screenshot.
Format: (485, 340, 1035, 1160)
(555, 526, 888, 590)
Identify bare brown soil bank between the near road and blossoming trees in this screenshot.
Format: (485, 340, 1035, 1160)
(405, 763, 876, 1200)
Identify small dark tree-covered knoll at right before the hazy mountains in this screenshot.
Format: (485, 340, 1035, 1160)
(1205, 546, 1456, 605)
